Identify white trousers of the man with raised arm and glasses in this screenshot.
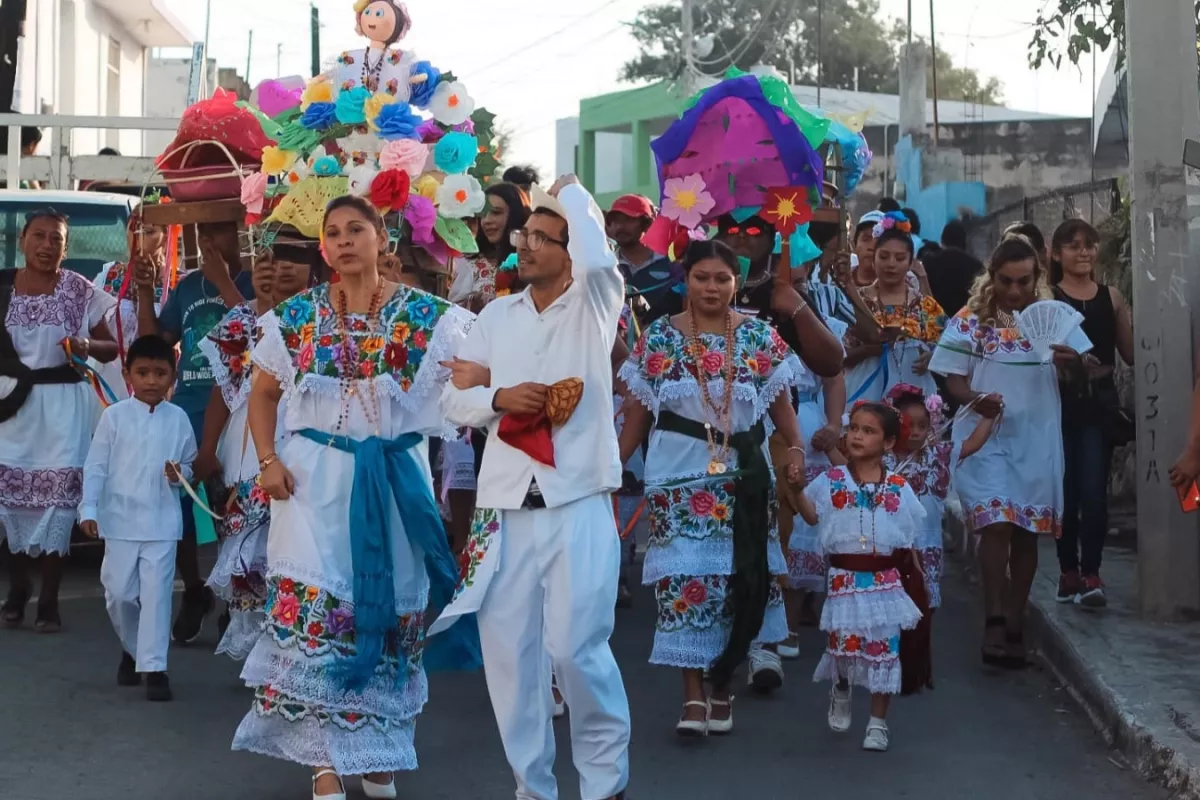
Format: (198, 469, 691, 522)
(479, 494, 629, 800)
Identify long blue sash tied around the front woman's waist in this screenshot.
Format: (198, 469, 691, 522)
(300, 428, 482, 691)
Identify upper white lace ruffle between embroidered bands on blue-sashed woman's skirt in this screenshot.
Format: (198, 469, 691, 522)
(241, 632, 430, 721)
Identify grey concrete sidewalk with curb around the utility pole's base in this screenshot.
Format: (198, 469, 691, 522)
(948, 510, 1200, 800)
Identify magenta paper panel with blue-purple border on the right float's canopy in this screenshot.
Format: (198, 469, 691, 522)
(652, 76, 823, 218)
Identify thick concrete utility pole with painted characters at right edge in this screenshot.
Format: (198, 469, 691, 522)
(1126, 0, 1200, 620)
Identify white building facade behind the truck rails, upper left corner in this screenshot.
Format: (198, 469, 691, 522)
(13, 0, 193, 156)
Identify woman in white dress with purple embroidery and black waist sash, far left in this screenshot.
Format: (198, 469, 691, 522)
(0, 211, 116, 632)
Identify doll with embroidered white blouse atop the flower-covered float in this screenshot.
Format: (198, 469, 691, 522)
(324, 0, 427, 102)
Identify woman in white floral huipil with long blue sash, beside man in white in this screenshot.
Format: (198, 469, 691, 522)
(233, 196, 472, 796)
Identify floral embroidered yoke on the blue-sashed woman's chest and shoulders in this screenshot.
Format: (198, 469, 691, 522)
(275, 284, 449, 392)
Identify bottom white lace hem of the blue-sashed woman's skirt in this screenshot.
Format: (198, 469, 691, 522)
(233, 709, 416, 775)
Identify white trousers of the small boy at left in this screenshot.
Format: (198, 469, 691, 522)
(100, 539, 178, 672)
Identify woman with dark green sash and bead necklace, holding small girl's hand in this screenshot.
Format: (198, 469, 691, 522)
(620, 242, 814, 735)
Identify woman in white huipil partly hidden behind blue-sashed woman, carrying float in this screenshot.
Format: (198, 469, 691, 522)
(197, 243, 316, 661)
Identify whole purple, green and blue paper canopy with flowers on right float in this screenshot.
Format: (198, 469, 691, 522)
(643, 68, 871, 266)
